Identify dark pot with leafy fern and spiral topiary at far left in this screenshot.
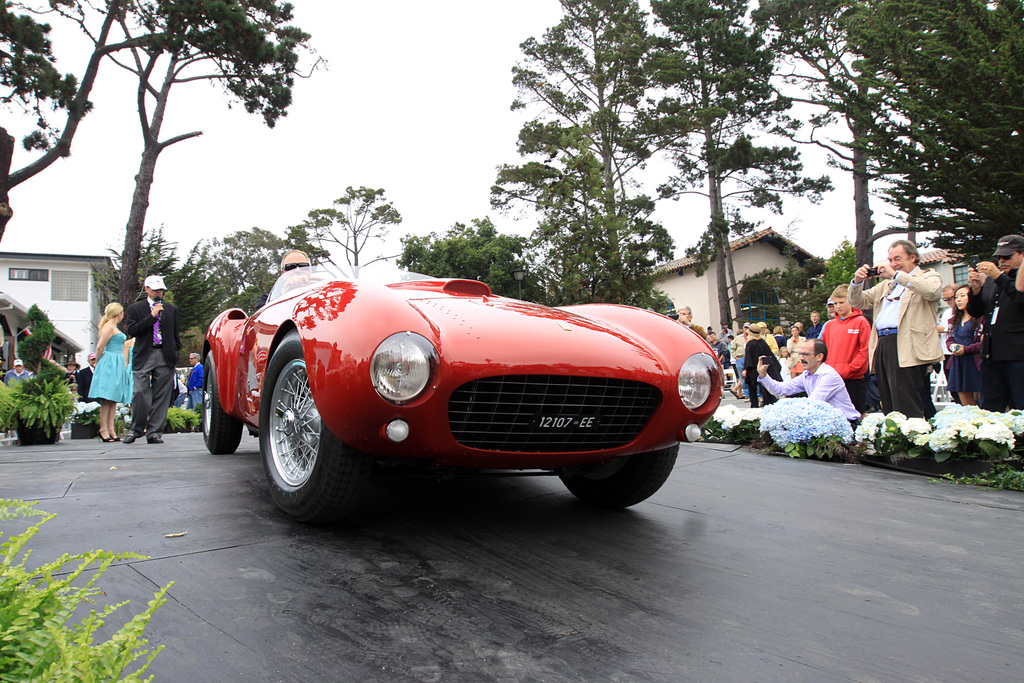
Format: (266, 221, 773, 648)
(0, 304, 75, 445)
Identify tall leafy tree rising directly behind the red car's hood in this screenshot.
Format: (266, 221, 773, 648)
(492, 0, 672, 305)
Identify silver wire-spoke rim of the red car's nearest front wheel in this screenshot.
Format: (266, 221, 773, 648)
(270, 360, 321, 486)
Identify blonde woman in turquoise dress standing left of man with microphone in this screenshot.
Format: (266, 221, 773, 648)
(89, 301, 131, 442)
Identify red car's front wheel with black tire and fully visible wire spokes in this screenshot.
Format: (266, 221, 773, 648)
(259, 332, 373, 522)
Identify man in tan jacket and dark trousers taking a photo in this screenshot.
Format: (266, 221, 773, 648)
(849, 240, 942, 418)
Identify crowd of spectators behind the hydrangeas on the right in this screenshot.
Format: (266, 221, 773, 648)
(681, 234, 1024, 422)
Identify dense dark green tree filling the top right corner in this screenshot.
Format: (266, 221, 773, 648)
(854, 0, 1024, 253)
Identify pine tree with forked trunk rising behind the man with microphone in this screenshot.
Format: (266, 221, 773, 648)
(108, 0, 310, 305)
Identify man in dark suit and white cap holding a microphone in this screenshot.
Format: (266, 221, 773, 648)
(123, 275, 181, 443)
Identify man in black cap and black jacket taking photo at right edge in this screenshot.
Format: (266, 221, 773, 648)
(967, 234, 1024, 413)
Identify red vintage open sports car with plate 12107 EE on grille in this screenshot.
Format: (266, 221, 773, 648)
(203, 266, 723, 521)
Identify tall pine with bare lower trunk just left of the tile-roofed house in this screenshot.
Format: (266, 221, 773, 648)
(651, 0, 830, 324)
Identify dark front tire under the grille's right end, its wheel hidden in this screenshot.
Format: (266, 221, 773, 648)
(558, 443, 679, 510)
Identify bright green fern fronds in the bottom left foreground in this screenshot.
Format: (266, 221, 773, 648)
(0, 500, 173, 683)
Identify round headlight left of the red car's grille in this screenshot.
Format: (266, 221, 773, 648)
(370, 332, 437, 403)
